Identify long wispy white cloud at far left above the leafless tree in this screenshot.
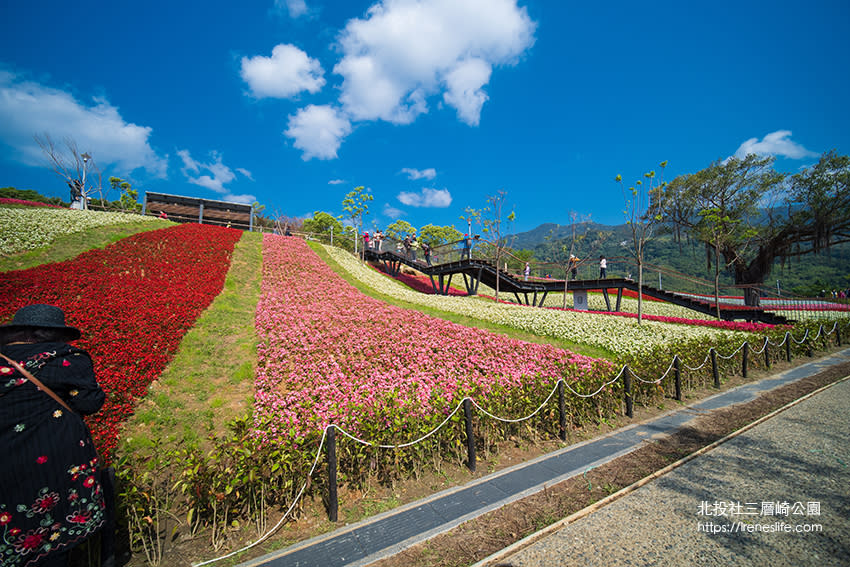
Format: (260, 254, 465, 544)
(0, 71, 168, 177)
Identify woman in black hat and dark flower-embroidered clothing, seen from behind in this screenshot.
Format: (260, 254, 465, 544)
(0, 305, 105, 567)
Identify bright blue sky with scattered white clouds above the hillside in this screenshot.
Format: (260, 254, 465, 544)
(0, 0, 850, 231)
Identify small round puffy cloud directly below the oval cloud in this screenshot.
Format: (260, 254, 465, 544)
(284, 104, 351, 161)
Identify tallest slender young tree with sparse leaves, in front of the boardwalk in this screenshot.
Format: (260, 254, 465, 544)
(615, 161, 669, 324)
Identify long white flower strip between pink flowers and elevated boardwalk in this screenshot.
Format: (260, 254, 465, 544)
(325, 246, 746, 354)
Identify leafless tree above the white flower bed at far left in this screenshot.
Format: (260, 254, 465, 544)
(33, 133, 103, 209)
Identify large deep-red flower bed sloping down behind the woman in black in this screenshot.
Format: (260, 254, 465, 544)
(0, 224, 242, 459)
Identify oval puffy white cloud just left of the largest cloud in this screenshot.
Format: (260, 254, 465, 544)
(240, 44, 325, 98)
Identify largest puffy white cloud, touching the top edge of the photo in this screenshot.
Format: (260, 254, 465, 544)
(334, 0, 536, 125)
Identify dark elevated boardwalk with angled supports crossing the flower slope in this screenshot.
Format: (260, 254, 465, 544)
(364, 248, 789, 325)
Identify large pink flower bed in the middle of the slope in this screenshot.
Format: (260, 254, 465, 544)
(255, 235, 611, 439)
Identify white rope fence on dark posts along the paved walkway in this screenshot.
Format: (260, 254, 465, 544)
(193, 321, 850, 567)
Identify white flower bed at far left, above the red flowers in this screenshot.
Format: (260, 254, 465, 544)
(0, 207, 156, 255)
